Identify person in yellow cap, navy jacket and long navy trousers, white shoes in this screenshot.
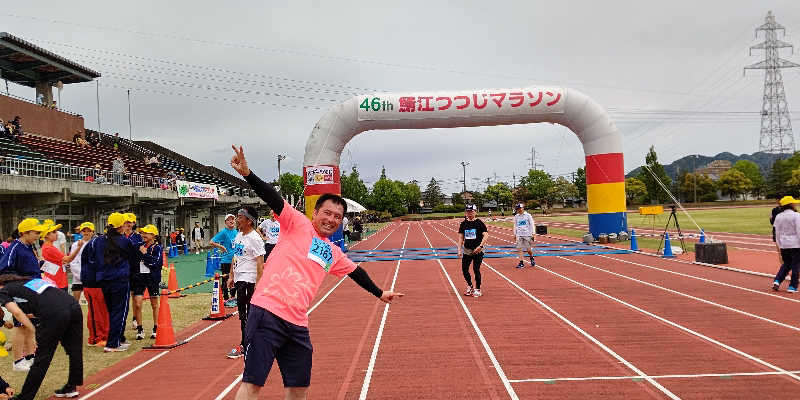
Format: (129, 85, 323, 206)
(81, 212, 139, 352)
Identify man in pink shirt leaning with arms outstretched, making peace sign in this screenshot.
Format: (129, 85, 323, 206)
(231, 146, 403, 400)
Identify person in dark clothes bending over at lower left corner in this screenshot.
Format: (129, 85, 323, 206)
(0, 274, 83, 400)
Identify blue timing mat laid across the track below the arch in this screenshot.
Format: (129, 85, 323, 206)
(347, 243, 630, 262)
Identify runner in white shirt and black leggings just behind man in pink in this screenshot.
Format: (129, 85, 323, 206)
(228, 206, 264, 358)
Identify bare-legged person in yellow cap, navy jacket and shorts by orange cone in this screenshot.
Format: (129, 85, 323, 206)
(131, 225, 164, 340)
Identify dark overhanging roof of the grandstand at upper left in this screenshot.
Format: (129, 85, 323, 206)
(0, 32, 100, 87)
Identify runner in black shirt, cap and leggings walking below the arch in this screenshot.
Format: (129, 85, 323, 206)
(458, 204, 487, 297)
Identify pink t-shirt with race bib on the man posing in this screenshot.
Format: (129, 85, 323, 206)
(250, 201, 356, 326)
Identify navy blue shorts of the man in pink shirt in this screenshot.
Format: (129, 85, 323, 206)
(242, 304, 313, 387)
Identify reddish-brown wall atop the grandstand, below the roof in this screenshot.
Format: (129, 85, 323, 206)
(0, 95, 84, 140)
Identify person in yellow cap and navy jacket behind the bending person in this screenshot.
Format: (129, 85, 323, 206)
(0, 218, 46, 371)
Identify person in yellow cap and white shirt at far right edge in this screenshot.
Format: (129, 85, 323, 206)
(772, 196, 800, 293)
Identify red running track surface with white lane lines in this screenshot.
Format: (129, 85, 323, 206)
(75, 221, 800, 400)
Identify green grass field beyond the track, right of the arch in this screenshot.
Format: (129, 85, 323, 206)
(535, 206, 773, 235)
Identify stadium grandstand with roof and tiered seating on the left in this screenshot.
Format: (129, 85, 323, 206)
(0, 32, 263, 240)
